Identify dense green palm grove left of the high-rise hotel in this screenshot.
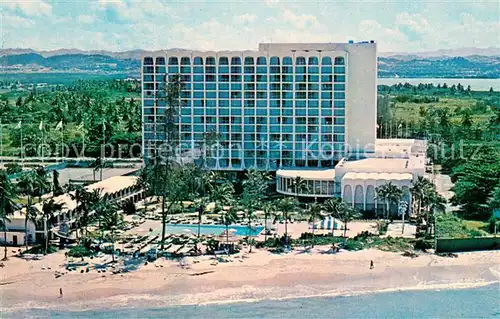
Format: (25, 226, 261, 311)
(0, 80, 141, 157)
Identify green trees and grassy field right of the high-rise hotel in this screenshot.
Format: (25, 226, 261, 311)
(378, 83, 500, 220)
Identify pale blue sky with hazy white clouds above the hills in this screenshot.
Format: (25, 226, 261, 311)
(0, 0, 500, 52)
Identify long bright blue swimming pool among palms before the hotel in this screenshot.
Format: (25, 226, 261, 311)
(167, 224, 264, 236)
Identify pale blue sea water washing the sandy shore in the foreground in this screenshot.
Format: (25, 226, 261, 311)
(11, 285, 500, 319)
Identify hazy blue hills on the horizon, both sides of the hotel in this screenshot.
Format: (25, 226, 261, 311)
(0, 48, 500, 78)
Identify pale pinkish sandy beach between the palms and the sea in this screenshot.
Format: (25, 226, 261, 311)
(0, 246, 500, 312)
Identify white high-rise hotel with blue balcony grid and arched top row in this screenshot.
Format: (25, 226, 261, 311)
(142, 41, 377, 170)
